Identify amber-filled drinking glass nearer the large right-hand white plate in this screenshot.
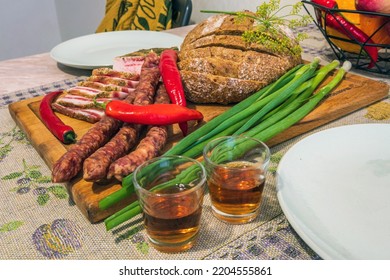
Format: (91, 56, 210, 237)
(203, 136, 270, 224)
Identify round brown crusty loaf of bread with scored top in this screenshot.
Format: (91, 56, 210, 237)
(178, 14, 302, 104)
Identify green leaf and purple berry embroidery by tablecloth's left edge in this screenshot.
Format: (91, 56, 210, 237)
(1, 159, 68, 205)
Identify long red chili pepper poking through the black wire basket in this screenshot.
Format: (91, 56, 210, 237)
(312, 0, 378, 68)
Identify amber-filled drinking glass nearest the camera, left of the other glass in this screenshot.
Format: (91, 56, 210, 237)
(133, 156, 206, 253)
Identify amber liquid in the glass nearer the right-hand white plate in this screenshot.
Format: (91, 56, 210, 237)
(208, 161, 265, 222)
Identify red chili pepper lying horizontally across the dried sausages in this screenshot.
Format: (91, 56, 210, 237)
(105, 100, 203, 125)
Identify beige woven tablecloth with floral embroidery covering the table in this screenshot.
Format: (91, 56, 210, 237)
(0, 25, 390, 260)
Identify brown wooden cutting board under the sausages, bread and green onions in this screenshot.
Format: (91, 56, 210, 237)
(9, 71, 389, 223)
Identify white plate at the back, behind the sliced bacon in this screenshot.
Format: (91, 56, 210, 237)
(50, 30, 184, 69)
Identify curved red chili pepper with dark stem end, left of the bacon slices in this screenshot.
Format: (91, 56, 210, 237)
(39, 91, 76, 144)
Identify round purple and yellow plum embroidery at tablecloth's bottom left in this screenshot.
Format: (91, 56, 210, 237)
(32, 219, 83, 259)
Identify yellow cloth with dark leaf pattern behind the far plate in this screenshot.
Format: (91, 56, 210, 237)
(96, 0, 172, 32)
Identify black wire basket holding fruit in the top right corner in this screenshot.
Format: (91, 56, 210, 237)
(301, 1, 390, 75)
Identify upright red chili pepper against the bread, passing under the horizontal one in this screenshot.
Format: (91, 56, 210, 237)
(159, 49, 188, 136)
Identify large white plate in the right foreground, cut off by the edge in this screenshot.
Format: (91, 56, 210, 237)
(277, 124, 390, 260)
